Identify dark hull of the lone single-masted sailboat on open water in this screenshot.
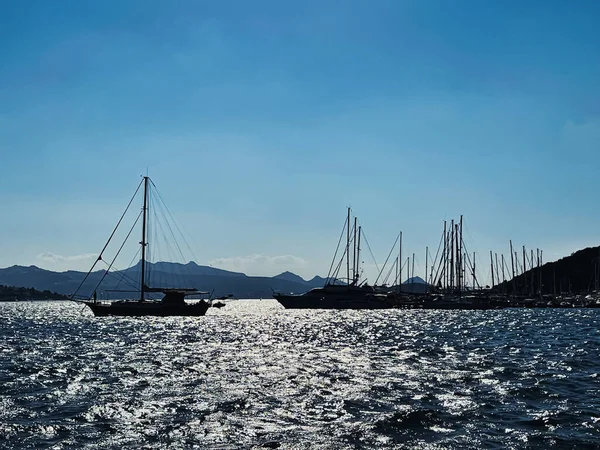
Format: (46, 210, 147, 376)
(85, 301, 210, 317)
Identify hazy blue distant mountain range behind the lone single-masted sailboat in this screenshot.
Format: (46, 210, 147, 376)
(0, 262, 332, 298)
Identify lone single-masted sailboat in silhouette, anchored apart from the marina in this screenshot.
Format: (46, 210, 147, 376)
(71, 176, 211, 317)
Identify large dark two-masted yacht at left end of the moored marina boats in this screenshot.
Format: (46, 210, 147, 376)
(273, 208, 396, 309)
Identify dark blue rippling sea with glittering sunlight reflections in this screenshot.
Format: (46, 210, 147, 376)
(0, 301, 600, 449)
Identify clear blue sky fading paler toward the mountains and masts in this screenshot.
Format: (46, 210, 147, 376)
(0, 0, 600, 281)
